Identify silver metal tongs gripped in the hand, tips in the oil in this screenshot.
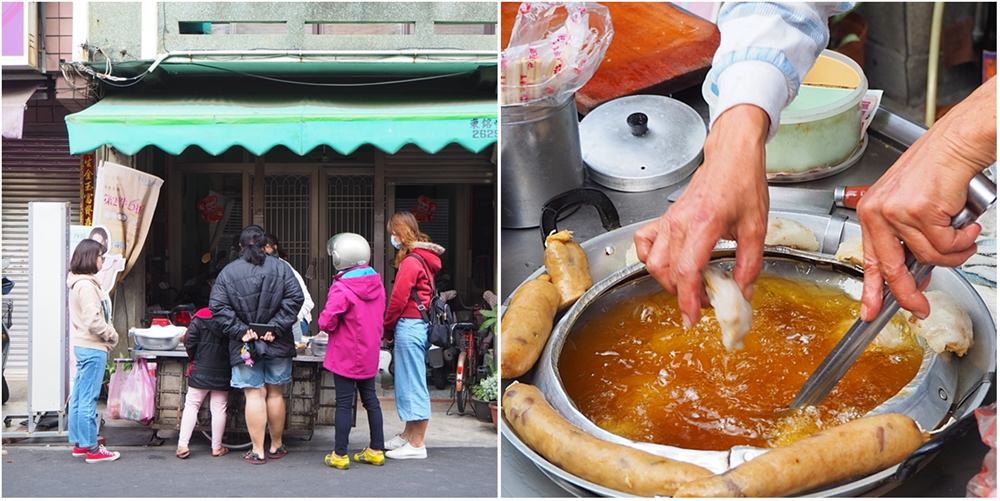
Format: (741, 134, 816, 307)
(791, 170, 997, 409)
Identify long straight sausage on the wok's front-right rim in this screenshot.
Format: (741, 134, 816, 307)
(674, 414, 924, 497)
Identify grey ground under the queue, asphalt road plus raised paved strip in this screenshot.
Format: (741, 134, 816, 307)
(2, 378, 497, 498)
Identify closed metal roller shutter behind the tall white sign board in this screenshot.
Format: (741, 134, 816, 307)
(2, 134, 80, 379)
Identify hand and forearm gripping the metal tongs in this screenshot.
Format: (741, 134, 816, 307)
(858, 77, 996, 321)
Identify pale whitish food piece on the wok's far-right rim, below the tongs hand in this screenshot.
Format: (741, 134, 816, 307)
(907, 291, 973, 357)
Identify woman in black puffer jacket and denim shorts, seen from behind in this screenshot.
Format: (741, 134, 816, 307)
(208, 225, 304, 464)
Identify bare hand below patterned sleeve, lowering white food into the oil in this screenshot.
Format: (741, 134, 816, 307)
(635, 104, 770, 326)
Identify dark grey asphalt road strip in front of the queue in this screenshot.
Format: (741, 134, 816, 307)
(3, 444, 497, 498)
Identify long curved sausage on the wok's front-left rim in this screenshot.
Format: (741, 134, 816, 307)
(503, 383, 712, 497)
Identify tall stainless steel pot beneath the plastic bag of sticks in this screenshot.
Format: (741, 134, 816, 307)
(500, 95, 584, 228)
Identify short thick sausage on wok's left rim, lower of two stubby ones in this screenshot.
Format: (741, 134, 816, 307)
(500, 275, 559, 378)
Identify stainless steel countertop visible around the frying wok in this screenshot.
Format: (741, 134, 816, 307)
(500, 87, 995, 497)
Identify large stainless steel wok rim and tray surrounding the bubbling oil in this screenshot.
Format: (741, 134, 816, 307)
(502, 207, 996, 496)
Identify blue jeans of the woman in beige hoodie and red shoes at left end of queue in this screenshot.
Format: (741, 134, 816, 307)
(68, 346, 108, 448)
